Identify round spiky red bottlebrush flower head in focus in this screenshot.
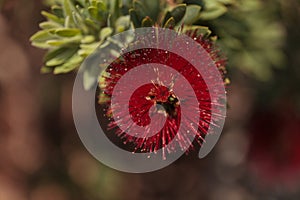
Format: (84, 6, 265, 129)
(100, 28, 225, 159)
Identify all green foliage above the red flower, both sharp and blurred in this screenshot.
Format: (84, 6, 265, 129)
(31, 0, 284, 82)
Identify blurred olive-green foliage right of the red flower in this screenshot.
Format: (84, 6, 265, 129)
(209, 0, 285, 80)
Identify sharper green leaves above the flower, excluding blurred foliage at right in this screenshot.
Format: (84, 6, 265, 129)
(30, 0, 227, 82)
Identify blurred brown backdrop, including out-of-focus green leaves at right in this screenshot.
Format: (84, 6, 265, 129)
(0, 0, 300, 200)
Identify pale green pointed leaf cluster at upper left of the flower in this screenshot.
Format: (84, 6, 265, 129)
(30, 0, 130, 74)
